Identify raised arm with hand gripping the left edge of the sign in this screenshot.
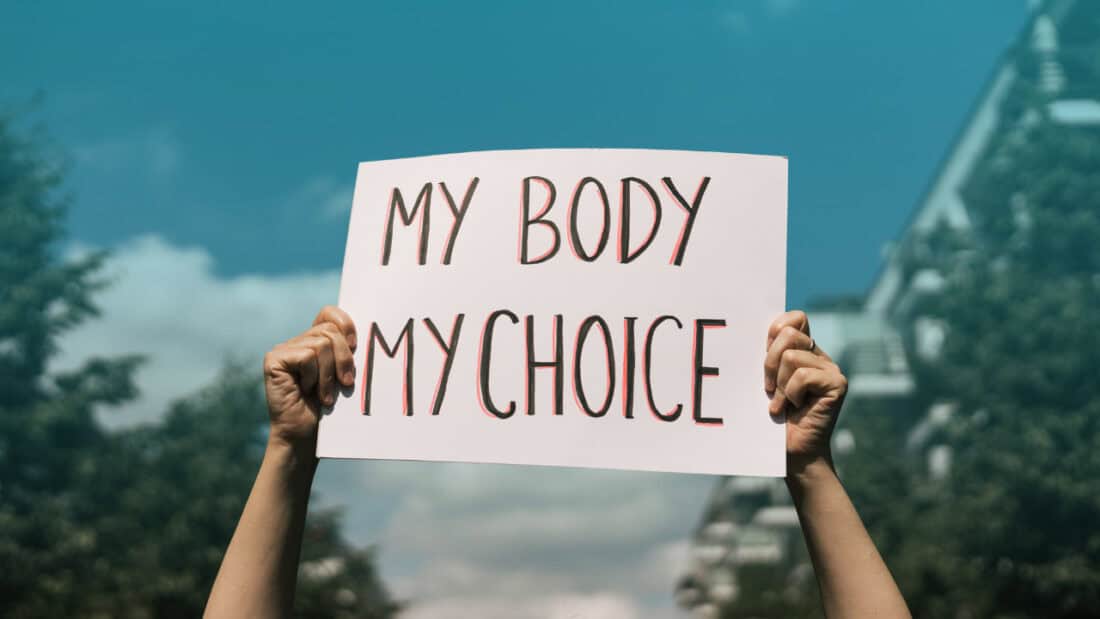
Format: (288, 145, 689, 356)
(206, 306, 355, 618)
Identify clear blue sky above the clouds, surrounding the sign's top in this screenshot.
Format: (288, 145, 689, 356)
(0, 0, 1025, 305)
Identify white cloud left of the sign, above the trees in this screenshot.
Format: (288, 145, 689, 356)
(54, 236, 339, 425)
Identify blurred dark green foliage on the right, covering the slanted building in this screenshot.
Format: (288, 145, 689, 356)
(729, 0, 1100, 619)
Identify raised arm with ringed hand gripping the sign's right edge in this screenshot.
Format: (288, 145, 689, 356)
(765, 311, 910, 618)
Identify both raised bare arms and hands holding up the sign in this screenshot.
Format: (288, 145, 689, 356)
(206, 307, 910, 617)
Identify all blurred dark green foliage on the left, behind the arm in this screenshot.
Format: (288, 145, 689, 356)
(0, 118, 397, 619)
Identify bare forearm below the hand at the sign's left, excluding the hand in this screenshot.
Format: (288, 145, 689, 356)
(206, 441, 317, 618)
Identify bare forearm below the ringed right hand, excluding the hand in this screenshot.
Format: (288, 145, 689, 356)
(787, 460, 910, 619)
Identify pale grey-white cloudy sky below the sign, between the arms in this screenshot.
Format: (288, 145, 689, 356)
(362, 462, 713, 617)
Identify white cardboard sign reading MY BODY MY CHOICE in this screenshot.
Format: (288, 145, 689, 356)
(317, 148, 787, 476)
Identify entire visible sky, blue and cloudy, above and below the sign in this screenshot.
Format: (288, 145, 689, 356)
(0, 0, 1026, 619)
